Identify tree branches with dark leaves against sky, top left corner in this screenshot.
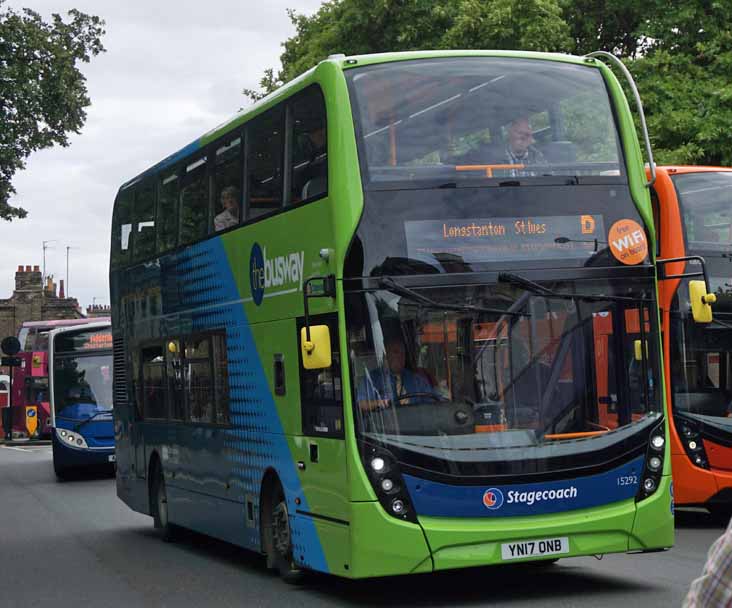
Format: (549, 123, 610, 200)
(0, 0, 104, 220)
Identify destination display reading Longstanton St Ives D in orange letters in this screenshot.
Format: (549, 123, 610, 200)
(404, 215, 605, 263)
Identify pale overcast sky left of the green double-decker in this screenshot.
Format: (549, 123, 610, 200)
(0, 0, 320, 308)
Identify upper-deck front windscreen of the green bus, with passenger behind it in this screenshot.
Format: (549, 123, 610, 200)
(346, 57, 623, 190)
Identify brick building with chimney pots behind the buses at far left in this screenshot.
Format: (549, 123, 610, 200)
(0, 266, 84, 339)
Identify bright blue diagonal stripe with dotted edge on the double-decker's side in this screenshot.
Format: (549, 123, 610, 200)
(171, 238, 328, 572)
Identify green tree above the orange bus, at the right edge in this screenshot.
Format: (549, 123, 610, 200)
(631, 0, 732, 165)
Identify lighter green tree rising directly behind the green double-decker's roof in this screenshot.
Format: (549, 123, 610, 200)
(244, 0, 572, 100)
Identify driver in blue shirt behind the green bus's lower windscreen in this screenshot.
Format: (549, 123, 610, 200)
(356, 336, 440, 410)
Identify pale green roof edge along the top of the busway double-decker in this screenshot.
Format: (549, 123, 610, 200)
(120, 50, 587, 191)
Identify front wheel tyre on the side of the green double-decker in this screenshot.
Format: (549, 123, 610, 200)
(263, 484, 304, 584)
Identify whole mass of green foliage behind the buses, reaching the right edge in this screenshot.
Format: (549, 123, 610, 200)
(245, 0, 732, 165)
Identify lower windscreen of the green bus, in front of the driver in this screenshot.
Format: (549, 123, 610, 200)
(346, 280, 660, 460)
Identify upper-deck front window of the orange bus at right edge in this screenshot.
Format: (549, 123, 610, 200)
(672, 171, 732, 250)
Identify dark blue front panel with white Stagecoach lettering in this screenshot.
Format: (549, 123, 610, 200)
(404, 456, 644, 517)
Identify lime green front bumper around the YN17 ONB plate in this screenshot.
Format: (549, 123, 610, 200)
(346, 476, 674, 578)
